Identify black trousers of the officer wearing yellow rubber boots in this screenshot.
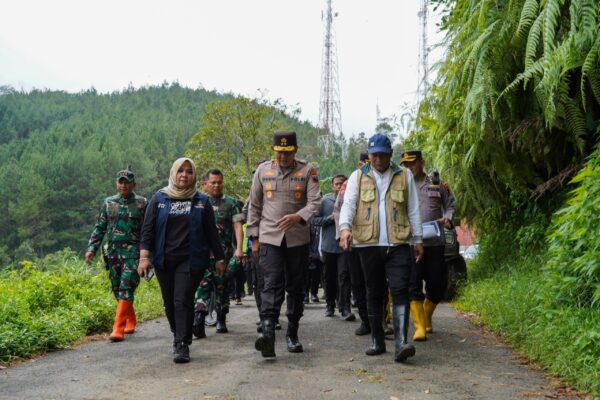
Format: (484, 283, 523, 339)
(410, 246, 448, 304)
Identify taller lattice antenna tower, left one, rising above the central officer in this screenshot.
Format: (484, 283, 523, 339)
(319, 0, 347, 159)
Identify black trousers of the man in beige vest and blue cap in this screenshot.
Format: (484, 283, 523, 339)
(355, 245, 412, 316)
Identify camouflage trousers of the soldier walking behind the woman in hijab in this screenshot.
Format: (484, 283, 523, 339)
(194, 260, 244, 314)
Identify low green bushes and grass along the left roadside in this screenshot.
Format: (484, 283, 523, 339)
(0, 251, 163, 361)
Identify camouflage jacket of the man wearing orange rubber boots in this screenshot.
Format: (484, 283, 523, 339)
(87, 194, 148, 259)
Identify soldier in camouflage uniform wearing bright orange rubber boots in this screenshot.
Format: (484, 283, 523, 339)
(85, 170, 148, 342)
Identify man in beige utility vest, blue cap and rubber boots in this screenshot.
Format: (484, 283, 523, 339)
(340, 134, 424, 362)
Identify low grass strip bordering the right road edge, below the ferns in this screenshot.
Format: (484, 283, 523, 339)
(455, 257, 600, 396)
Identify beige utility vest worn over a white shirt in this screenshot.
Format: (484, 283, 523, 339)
(352, 166, 410, 245)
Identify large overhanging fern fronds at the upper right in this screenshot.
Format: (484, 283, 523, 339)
(408, 0, 600, 229)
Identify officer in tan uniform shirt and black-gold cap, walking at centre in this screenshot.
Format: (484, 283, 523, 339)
(246, 131, 321, 357)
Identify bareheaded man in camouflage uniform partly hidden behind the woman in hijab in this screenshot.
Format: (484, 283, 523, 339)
(193, 169, 244, 338)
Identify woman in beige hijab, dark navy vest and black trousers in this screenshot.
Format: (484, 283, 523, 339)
(138, 157, 225, 363)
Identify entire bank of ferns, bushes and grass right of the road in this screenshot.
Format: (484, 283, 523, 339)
(404, 0, 600, 396)
